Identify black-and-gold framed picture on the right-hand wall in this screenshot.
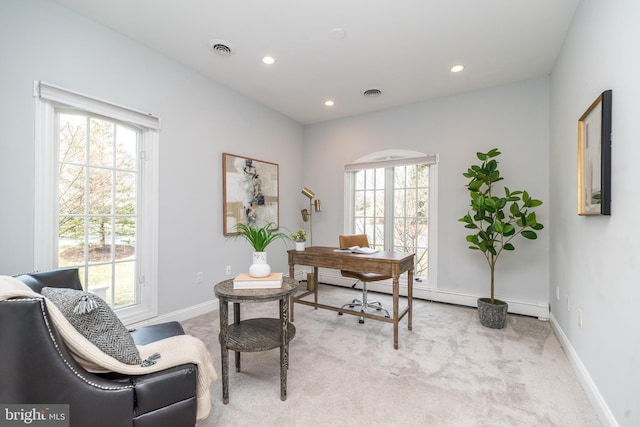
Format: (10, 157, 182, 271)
(578, 90, 611, 215)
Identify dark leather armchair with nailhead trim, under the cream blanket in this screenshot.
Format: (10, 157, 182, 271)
(0, 269, 197, 427)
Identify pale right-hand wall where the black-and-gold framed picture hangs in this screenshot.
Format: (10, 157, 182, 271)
(550, 0, 640, 426)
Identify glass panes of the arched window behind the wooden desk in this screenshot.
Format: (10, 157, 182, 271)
(345, 154, 437, 284)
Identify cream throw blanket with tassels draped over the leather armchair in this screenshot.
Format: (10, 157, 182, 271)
(0, 276, 217, 420)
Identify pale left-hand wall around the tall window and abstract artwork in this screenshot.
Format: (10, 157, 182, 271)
(0, 0, 302, 315)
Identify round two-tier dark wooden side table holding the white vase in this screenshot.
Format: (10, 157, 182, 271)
(214, 277, 299, 405)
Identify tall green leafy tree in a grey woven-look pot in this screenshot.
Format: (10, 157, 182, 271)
(458, 148, 544, 329)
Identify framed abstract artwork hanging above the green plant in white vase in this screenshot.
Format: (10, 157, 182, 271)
(222, 153, 279, 236)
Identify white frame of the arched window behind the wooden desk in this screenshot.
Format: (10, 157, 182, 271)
(343, 150, 439, 289)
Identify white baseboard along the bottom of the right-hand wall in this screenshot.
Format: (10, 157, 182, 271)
(550, 314, 619, 427)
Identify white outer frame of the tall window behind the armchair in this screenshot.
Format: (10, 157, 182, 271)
(33, 81, 160, 325)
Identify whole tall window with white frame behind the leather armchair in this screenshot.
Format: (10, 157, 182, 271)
(35, 83, 158, 323)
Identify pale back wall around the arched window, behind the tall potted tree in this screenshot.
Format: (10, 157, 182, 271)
(299, 78, 549, 312)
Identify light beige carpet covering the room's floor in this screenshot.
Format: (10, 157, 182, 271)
(183, 285, 600, 427)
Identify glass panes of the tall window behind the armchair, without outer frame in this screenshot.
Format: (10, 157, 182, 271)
(55, 109, 141, 307)
